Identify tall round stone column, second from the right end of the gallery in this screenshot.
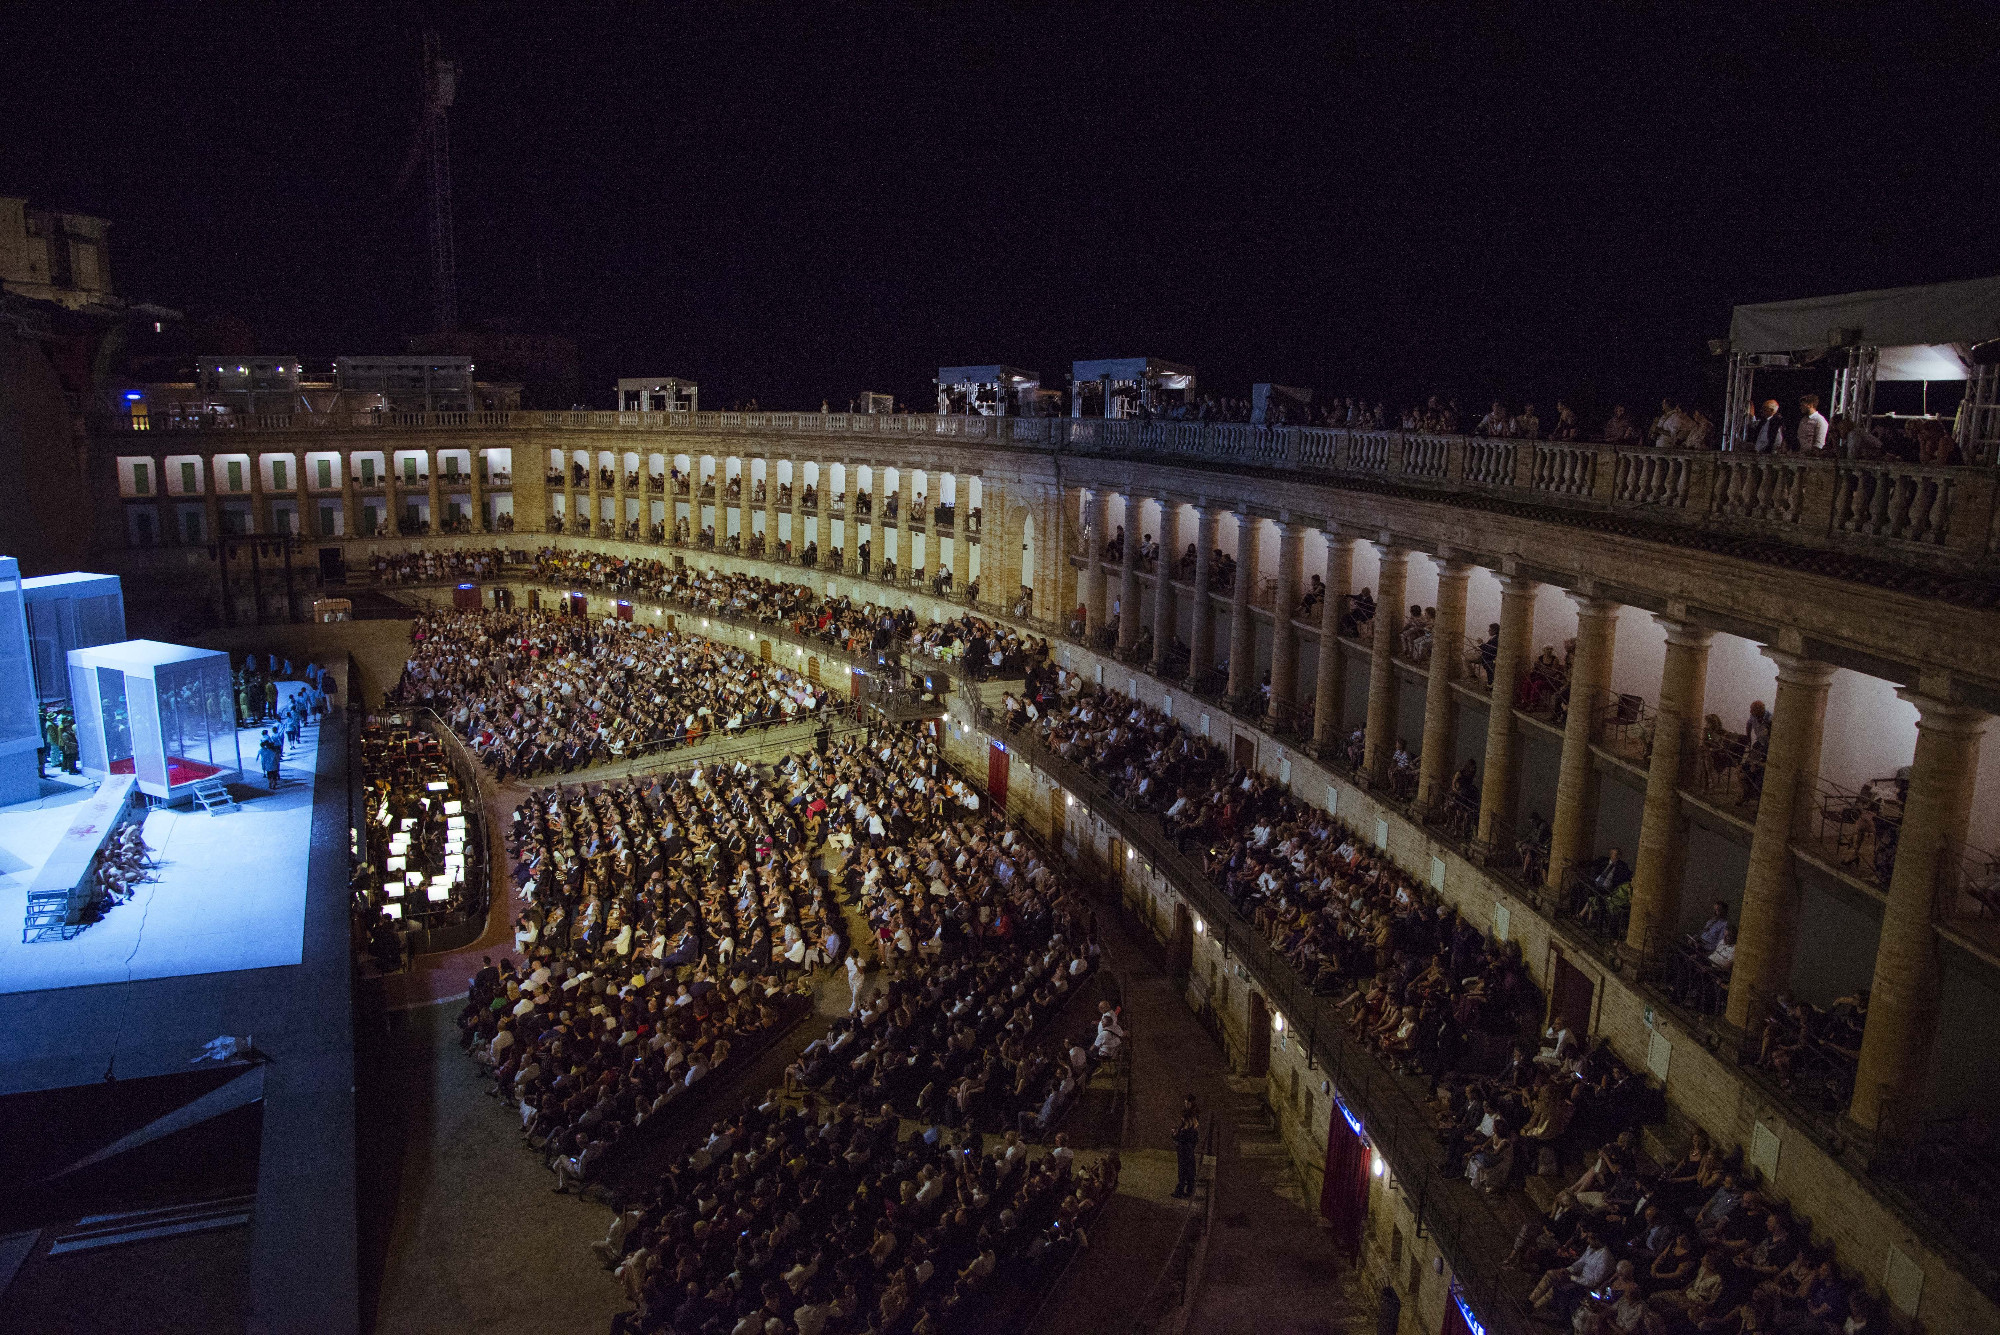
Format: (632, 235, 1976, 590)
(1728, 646, 1834, 1029)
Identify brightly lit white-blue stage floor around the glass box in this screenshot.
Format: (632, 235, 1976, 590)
(0, 681, 320, 993)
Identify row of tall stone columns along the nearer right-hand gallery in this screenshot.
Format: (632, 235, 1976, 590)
(1066, 479, 1988, 1135)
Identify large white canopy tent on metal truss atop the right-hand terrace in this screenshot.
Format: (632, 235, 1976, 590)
(1724, 278, 2000, 462)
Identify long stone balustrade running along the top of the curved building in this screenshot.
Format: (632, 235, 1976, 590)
(98, 412, 2000, 572)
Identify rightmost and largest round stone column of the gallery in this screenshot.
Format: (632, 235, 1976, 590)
(1848, 691, 1990, 1135)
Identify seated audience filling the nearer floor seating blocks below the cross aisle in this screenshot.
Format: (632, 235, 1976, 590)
(440, 727, 1122, 1335)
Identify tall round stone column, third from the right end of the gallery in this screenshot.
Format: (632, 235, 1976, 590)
(1626, 616, 1712, 959)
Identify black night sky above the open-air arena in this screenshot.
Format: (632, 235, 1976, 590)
(0, 4, 2000, 408)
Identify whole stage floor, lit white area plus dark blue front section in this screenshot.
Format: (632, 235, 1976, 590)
(0, 671, 358, 1335)
